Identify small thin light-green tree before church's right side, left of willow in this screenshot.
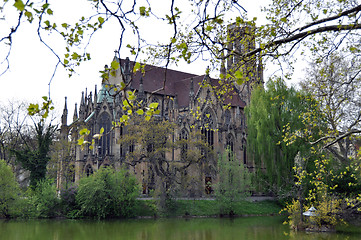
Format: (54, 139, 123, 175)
(215, 149, 251, 216)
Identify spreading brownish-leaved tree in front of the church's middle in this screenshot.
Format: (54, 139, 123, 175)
(121, 117, 212, 203)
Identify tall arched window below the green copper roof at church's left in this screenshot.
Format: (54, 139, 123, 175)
(98, 112, 111, 156)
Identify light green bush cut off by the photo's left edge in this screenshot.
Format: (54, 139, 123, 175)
(0, 160, 20, 218)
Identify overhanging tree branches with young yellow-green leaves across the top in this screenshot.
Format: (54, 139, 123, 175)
(0, 0, 361, 105)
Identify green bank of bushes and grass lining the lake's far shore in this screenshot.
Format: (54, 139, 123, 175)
(0, 161, 281, 219)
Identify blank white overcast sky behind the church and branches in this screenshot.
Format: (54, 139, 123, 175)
(0, 0, 282, 119)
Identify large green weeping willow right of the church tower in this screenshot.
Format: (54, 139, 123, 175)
(247, 79, 322, 197)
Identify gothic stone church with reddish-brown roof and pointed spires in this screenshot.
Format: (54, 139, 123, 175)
(57, 23, 263, 196)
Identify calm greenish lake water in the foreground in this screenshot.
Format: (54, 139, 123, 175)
(0, 216, 361, 240)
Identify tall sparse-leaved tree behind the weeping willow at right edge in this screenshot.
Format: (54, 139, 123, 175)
(301, 53, 361, 166)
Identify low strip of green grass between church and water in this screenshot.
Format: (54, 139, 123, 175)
(132, 200, 282, 217)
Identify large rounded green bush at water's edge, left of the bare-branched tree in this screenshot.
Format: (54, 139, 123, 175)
(76, 168, 139, 219)
